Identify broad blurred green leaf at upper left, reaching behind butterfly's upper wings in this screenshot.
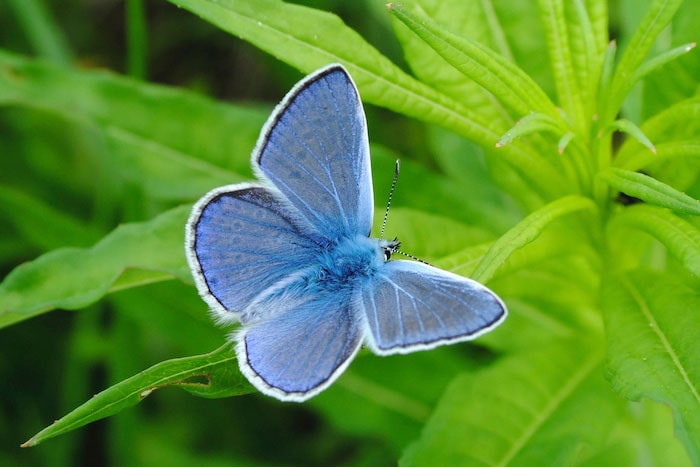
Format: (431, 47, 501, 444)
(0, 51, 269, 184)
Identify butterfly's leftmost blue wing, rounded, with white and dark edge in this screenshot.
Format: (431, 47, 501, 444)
(186, 184, 320, 322)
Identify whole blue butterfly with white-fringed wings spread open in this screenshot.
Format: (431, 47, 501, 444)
(186, 65, 507, 401)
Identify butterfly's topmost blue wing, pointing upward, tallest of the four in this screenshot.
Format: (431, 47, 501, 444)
(254, 65, 374, 240)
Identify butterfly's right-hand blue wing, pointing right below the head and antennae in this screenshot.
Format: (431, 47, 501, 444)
(358, 261, 507, 354)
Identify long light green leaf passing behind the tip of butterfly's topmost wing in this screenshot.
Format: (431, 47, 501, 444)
(164, 0, 495, 141)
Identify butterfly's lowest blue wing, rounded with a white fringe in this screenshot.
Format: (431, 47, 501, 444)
(236, 292, 363, 401)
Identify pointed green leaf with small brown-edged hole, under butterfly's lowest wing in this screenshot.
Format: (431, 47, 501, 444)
(22, 344, 252, 447)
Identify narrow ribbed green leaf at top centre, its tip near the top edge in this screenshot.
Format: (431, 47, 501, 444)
(388, 3, 558, 117)
